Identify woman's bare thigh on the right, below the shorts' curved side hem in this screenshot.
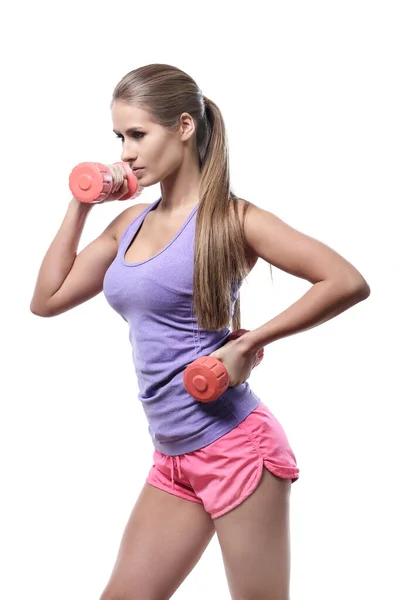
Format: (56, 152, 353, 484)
(214, 467, 291, 600)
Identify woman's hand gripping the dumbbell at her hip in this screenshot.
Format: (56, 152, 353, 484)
(209, 334, 259, 387)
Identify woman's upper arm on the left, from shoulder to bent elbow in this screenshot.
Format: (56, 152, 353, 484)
(39, 204, 147, 317)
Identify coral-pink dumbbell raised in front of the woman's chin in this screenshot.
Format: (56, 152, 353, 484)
(69, 162, 143, 203)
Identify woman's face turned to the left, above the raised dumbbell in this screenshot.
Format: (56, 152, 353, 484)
(111, 100, 189, 187)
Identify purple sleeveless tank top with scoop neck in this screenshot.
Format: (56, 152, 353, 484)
(103, 198, 260, 456)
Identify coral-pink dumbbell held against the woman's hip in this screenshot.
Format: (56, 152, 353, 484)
(183, 329, 264, 402)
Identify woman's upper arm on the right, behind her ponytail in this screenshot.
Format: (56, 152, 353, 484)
(244, 203, 368, 289)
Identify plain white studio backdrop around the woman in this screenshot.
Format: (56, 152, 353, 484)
(0, 0, 400, 600)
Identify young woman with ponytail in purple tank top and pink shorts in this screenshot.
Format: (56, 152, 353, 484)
(31, 64, 369, 600)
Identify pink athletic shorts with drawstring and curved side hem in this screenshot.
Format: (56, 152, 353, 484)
(146, 402, 299, 519)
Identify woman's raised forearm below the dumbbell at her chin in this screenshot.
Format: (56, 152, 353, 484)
(31, 198, 93, 310)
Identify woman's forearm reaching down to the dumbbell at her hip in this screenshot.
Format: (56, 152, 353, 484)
(240, 280, 369, 351)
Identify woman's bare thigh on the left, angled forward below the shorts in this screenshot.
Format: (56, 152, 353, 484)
(100, 483, 215, 600)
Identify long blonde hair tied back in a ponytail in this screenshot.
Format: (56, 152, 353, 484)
(112, 64, 250, 330)
